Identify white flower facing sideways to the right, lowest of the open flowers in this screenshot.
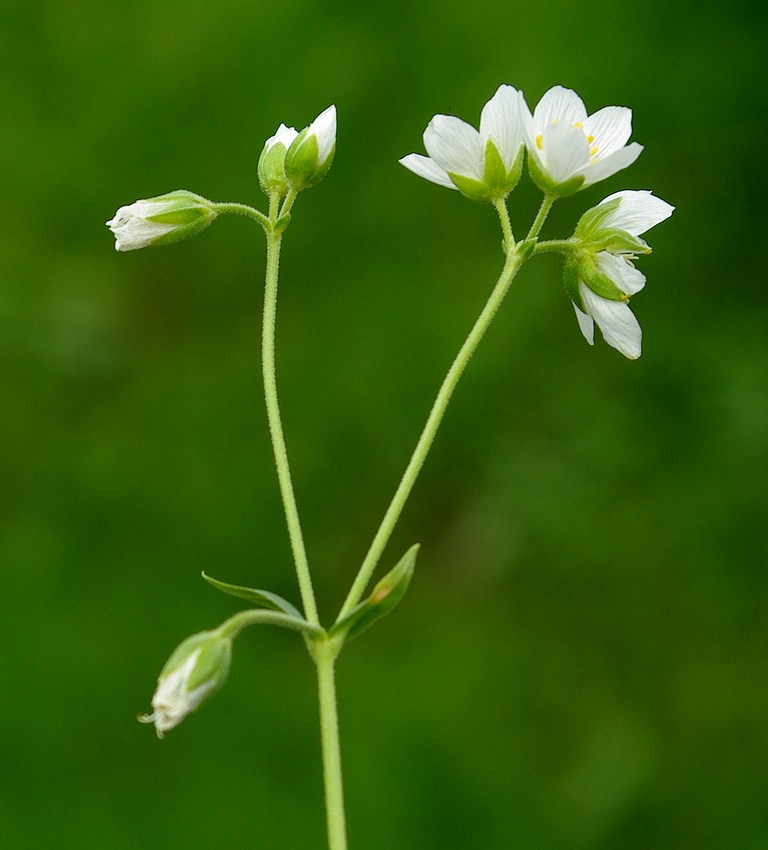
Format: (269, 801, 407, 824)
(566, 191, 675, 360)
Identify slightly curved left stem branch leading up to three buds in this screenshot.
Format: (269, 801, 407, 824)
(261, 215, 320, 626)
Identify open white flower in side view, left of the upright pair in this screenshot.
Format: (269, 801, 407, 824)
(400, 86, 527, 201)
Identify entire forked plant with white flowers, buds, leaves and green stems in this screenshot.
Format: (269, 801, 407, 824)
(107, 85, 673, 850)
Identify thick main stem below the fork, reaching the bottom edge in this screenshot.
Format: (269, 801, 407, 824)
(311, 640, 347, 850)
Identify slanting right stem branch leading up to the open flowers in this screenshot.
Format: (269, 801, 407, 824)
(337, 242, 524, 622)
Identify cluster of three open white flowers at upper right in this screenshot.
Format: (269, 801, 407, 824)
(400, 85, 674, 359)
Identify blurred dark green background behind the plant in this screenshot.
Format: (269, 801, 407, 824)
(0, 0, 768, 850)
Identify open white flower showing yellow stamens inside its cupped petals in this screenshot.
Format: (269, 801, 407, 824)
(525, 86, 643, 195)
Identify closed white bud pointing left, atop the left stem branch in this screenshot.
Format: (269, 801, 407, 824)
(107, 189, 217, 251)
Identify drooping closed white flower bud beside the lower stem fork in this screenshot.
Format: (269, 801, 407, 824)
(139, 631, 232, 738)
